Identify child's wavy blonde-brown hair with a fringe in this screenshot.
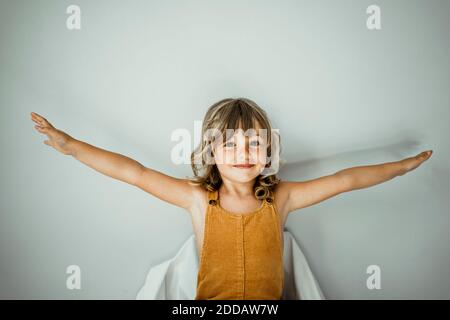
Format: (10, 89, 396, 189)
(189, 98, 281, 200)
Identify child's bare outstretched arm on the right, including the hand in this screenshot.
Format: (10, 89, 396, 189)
(280, 150, 432, 213)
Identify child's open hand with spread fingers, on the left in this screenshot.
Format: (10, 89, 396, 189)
(31, 112, 74, 155)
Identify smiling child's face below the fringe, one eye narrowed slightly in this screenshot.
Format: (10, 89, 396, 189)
(214, 128, 267, 182)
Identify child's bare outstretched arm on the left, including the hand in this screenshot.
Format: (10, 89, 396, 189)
(31, 112, 194, 209)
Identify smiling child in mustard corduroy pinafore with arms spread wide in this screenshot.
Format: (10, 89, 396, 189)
(31, 98, 432, 300)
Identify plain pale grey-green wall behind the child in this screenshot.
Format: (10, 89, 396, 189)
(0, 0, 450, 299)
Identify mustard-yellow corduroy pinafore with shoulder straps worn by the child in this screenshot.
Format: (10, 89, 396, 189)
(195, 190, 284, 300)
